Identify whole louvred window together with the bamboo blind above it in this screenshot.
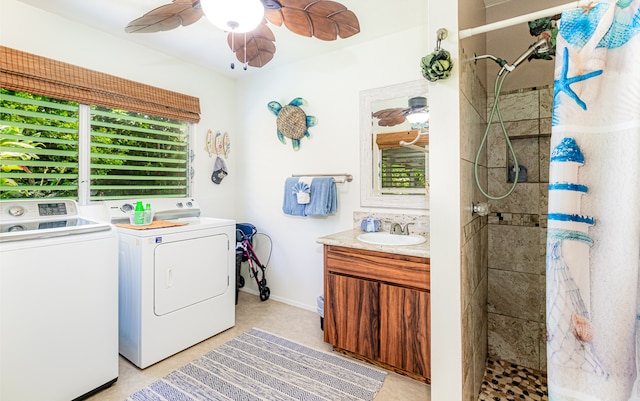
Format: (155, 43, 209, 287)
(0, 46, 200, 203)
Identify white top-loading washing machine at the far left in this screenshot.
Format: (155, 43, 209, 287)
(0, 199, 118, 401)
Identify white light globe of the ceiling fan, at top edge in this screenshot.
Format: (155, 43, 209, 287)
(200, 0, 264, 33)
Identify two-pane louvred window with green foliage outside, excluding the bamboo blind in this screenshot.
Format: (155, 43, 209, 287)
(0, 89, 188, 201)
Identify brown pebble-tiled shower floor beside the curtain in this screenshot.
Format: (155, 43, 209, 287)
(478, 359, 549, 401)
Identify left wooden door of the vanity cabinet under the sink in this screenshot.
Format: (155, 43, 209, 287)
(324, 274, 380, 358)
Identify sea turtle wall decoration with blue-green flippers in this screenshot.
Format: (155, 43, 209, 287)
(267, 97, 318, 150)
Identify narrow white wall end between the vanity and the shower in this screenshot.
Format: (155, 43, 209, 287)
(428, 1, 463, 401)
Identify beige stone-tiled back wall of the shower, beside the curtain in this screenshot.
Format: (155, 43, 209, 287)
(487, 87, 553, 371)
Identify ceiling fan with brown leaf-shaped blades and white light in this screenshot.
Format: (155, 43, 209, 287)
(125, 0, 360, 69)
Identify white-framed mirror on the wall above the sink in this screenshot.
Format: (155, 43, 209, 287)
(360, 80, 429, 209)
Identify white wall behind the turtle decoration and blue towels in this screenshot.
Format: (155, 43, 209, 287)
(232, 26, 427, 310)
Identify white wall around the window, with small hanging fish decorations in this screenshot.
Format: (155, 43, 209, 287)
(0, 0, 240, 218)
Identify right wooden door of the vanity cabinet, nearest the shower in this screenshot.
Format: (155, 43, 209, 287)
(380, 284, 431, 378)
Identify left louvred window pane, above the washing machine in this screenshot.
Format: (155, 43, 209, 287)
(0, 89, 79, 199)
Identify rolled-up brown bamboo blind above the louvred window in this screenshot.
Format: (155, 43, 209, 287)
(0, 46, 200, 123)
